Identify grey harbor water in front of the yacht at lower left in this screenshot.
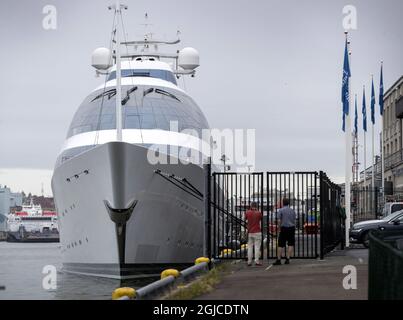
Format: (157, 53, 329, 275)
(0, 242, 155, 300)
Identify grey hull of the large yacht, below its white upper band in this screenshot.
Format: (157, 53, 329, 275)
(52, 142, 203, 279)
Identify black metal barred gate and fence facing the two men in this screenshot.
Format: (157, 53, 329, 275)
(208, 172, 343, 259)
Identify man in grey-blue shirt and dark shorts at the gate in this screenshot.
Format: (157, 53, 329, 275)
(274, 199, 296, 265)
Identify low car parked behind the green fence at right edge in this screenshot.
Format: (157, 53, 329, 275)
(350, 210, 403, 248)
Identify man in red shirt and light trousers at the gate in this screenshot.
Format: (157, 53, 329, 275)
(245, 202, 263, 266)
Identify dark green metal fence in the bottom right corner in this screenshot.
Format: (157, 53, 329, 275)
(368, 231, 403, 300)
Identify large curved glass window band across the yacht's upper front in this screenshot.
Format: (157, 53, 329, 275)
(67, 87, 209, 138)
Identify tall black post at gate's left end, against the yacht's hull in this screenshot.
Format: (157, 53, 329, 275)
(203, 157, 211, 258)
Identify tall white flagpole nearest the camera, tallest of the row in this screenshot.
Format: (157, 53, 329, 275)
(344, 36, 352, 248)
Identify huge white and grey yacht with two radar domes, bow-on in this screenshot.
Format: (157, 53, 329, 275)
(52, 3, 209, 279)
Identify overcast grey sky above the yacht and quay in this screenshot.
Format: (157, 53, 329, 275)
(0, 0, 403, 194)
